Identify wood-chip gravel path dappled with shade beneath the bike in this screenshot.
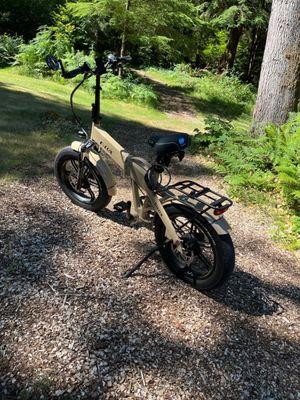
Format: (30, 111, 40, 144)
(0, 82, 300, 400)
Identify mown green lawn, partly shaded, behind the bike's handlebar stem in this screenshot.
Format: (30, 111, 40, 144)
(0, 68, 203, 179)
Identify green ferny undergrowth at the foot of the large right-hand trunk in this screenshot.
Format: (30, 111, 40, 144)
(192, 113, 300, 248)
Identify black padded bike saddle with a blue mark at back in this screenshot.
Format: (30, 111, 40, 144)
(148, 133, 191, 156)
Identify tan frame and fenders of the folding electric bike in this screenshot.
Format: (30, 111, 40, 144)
(71, 123, 230, 248)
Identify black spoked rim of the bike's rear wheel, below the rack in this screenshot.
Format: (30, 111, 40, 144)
(171, 215, 216, 283)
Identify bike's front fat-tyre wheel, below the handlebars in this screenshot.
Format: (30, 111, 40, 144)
(54, 147, 111, 211)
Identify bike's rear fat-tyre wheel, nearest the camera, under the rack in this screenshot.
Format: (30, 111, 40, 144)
(154, 205, 235, 290)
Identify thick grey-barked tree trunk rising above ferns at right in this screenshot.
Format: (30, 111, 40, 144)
(253, 0, 300, 133)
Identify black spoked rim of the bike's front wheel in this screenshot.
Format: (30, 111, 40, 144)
(62, 159, 101, 204)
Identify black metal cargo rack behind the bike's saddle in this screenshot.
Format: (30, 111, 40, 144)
(159, 180, 233, 215)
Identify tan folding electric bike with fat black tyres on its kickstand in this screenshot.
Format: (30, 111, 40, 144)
(46, 55, 235, 290)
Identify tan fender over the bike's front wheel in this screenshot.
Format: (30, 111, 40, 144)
(71, 141, 117, 196)
